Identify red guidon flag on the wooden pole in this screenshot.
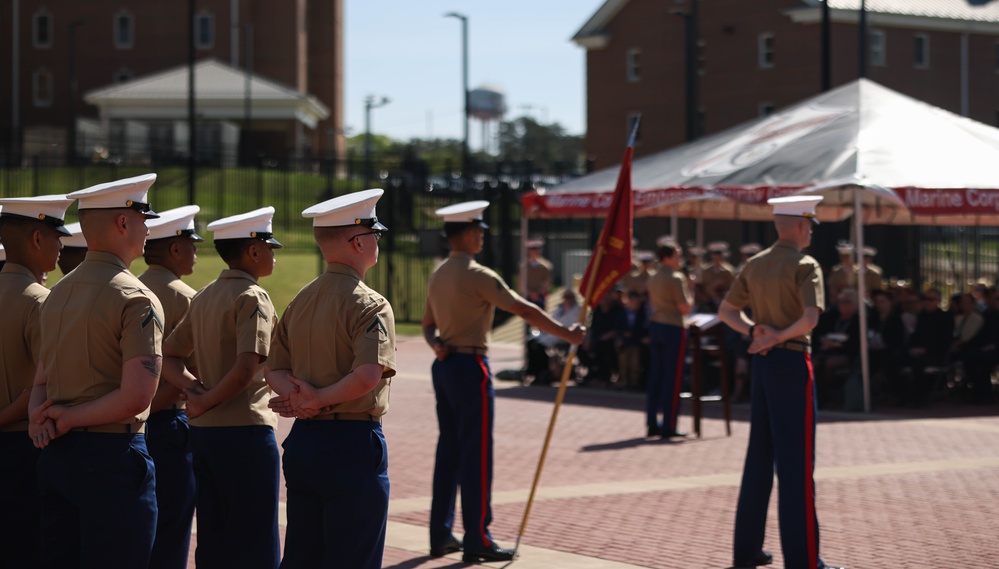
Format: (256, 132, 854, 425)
(579, 120, 638, 307)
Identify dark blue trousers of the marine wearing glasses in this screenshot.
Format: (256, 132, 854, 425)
(281, 414, 389, 569)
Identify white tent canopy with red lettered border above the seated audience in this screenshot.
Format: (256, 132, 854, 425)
(525, 79, 999, 225)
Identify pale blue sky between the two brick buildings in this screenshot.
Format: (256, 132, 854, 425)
(344, 0, 604, 144)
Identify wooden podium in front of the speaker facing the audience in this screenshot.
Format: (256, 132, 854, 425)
(687, 314, 732, 438)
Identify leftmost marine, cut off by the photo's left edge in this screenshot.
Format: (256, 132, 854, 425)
(0, 195, 72, 567)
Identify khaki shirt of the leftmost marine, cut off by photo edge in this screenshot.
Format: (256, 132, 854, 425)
(0, 263, 49, 432)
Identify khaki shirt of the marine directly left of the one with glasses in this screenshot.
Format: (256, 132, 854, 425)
(164, 269, 277, 427)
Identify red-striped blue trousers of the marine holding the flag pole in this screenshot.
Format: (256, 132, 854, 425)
(430, 354, 493, 551)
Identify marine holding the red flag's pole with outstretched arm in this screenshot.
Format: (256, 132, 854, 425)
(422, 201, 586, 563)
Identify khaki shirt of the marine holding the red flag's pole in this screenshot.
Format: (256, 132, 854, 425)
(425, 252, 526, 349)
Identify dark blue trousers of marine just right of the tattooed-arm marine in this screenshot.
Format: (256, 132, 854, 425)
(146, 409, 197, 569)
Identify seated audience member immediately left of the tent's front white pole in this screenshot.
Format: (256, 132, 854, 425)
(812, 288, 860, 408)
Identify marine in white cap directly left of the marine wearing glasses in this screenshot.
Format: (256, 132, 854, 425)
(163, 207, 281, 569)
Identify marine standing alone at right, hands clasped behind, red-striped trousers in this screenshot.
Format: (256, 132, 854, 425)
(718, 196, 831, 569)
